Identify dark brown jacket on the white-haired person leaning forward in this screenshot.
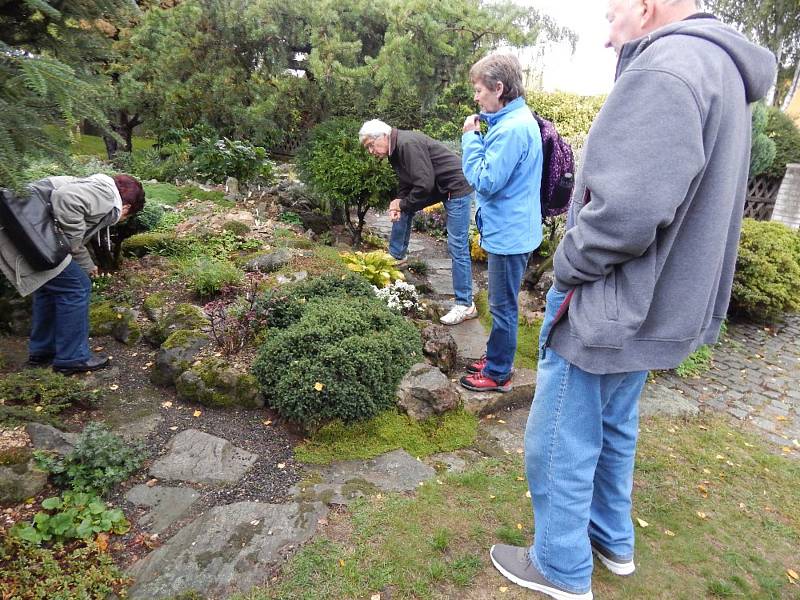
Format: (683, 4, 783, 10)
(389, 129, 472, 212)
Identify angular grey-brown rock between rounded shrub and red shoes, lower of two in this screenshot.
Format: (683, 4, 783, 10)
(396, 363, 460, 421)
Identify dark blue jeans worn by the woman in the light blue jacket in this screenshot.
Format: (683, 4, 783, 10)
(483, 252, 528, 383)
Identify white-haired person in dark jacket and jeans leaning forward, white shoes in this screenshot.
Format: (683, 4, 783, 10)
(358, 119, 478, 325)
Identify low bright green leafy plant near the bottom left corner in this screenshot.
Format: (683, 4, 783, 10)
(9, 492, 131, 545)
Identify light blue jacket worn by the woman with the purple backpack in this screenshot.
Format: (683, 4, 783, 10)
(461, 98, 542, 254)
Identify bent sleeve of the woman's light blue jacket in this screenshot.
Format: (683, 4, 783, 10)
(461, 129, 527, 197)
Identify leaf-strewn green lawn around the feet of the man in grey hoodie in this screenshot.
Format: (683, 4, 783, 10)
(237, 420, 800, 600)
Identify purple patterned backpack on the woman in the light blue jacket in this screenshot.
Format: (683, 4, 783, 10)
(533, 113, 575, 217)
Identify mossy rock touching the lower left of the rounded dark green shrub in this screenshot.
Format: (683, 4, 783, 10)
(175, 357, 264, 408)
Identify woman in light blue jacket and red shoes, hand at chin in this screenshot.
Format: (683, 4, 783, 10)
(461, 54, 542, 392)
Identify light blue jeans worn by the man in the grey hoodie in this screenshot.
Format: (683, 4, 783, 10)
(525, 288, 647, 593)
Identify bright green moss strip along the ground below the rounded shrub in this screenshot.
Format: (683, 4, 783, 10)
(295, 410, 478, 464)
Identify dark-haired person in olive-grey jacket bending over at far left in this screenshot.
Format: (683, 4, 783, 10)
(0, 174, 144, 373)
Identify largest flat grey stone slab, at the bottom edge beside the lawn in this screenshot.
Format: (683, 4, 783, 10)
(128, 502, 327, 600)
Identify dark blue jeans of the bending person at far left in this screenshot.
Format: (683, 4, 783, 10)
(28, 260, 92, 367)
